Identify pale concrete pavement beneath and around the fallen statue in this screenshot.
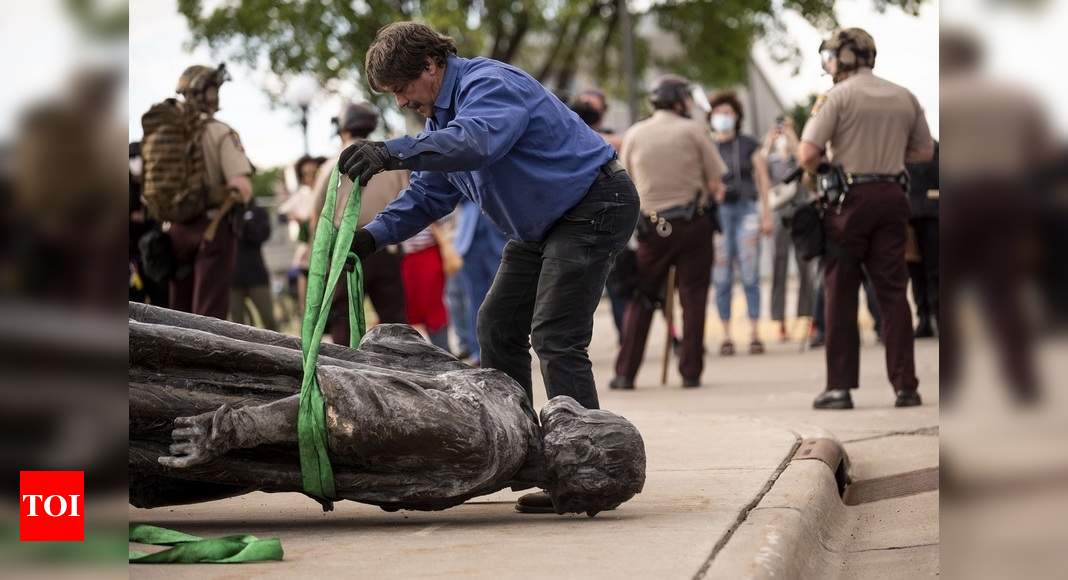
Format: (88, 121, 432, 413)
(129, 303, 938, 578)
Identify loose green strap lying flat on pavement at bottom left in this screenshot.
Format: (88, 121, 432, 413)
(129, 523, 283, 564)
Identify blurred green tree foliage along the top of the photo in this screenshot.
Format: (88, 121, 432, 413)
(178, 0, 925, 110)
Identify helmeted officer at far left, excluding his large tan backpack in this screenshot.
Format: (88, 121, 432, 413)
(169, 65, 252, 319)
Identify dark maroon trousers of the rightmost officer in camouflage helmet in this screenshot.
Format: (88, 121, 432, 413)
(823, 184, 918, 391)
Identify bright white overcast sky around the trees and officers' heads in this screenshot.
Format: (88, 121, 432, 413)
(128, 0, 939, 168)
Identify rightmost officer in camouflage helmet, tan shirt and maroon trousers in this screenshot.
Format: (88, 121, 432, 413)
(798, 28, 933, 409)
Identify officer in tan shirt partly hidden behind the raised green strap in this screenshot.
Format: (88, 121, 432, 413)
(312, 103, 408, 345)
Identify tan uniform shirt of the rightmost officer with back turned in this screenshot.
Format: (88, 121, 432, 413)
(801, 68, 931, 174)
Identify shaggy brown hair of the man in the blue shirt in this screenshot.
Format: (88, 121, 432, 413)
(364, 22, 456, 92)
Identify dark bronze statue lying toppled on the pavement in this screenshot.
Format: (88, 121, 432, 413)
(128, 302, 645, 516)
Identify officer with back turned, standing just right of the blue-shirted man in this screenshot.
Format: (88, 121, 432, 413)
(611, 75, 726, 389)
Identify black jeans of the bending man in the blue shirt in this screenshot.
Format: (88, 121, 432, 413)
(477, 171, 638, 409)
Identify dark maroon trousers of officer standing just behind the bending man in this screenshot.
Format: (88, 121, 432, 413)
(615, 216, 714, 380)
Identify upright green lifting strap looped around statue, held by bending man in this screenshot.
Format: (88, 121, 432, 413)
(297, 166, 366, 512)
